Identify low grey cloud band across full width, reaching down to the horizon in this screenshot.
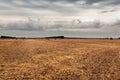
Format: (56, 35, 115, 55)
(0, 20, 120, 37)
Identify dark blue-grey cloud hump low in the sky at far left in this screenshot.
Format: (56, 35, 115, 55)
(0, 21, 44, 31)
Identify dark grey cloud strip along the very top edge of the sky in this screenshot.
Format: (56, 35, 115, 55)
(0, 0, 120, 8)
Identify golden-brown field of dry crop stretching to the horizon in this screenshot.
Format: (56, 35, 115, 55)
(0, 39, 120, 80)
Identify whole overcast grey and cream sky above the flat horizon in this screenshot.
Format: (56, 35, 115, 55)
(0, 0, 120, 37)
